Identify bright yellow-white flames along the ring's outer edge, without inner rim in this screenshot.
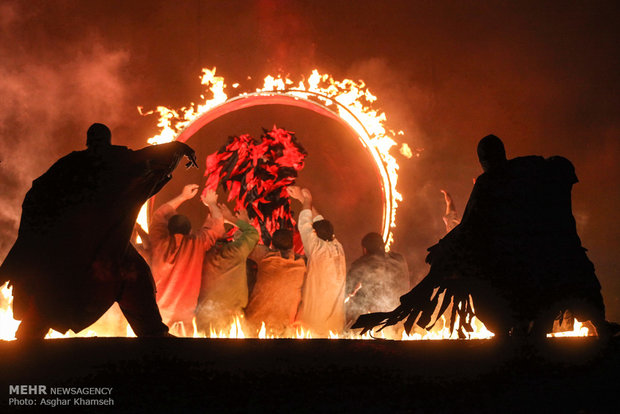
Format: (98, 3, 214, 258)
(143, 68, 412, 248)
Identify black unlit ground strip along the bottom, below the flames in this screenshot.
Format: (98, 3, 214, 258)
(0, 338, 620, 413)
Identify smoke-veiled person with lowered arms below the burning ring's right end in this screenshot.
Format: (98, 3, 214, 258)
(345, 233, 410, 336)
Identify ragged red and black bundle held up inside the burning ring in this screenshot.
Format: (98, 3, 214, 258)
(205, 127, 307, 246)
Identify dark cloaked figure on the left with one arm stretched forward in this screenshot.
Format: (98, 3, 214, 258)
(0, 124, 195, 339)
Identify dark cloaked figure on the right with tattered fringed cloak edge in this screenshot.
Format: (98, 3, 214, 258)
(354, 135, 609, 337)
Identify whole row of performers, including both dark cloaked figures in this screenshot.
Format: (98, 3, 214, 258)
(0, 124, 610, 339)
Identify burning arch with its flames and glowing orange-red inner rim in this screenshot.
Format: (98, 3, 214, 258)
(139, 68, 411, 247)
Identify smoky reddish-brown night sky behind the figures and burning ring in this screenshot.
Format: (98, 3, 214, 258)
(0, 0, 620, 321)
